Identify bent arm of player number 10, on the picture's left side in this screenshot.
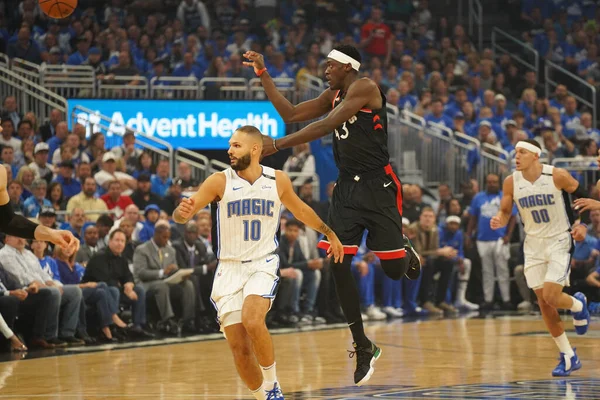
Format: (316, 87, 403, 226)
(173, 172, 225, 224)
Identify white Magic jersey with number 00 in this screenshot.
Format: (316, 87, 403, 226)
(513, 164, 574, 238)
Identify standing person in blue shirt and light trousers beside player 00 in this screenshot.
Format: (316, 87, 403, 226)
(467, 174, 516, 309)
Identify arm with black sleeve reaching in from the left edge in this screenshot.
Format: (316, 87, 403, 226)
(0, 165, 79, 250)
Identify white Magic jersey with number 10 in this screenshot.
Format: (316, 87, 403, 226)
(216, 166, 281, 261)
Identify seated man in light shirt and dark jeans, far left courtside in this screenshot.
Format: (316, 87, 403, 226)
(0, 235, 85, 347)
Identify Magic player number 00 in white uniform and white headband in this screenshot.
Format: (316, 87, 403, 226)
(490, 140, 590, 376)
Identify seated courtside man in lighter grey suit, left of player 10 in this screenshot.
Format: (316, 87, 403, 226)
(133, 224, 196, 333)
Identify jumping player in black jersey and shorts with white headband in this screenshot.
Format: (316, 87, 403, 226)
(244, 45, 421, 386)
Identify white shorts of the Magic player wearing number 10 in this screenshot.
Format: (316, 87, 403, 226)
(210, 254, 279, 331)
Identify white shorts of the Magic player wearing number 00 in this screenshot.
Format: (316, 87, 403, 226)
(524, 232, 573, 289)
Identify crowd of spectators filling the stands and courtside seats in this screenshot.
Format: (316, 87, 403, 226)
(0, 0, 600, 348)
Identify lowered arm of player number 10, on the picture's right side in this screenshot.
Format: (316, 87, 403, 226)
(275, 171, 344, 262)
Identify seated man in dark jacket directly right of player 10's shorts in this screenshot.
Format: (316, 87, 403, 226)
(277, 219, 323, 324)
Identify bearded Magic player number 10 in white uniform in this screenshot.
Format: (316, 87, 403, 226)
(173, 126, 344, 400)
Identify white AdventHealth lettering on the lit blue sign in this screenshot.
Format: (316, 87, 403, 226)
(78, 111, 278, 139)
